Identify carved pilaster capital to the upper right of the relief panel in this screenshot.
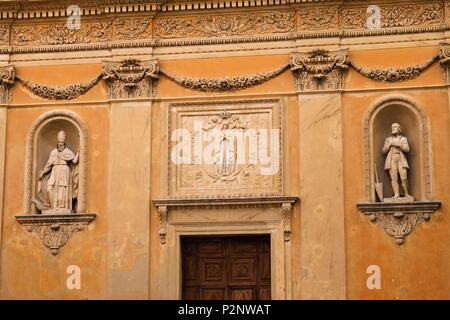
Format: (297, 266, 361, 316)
(291, 49, 349, 91)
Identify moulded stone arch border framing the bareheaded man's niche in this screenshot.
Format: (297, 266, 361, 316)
(363, 95, 432, 202)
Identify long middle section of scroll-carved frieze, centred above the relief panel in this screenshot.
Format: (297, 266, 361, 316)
(155, 10, 295, 39)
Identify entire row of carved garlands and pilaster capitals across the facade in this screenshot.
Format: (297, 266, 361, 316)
(0, 45, 450, 100)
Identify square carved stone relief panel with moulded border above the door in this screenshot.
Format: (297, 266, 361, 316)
(168, 99, 282, 198)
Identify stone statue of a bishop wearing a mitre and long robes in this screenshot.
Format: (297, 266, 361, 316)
(33, 130, 79, 214)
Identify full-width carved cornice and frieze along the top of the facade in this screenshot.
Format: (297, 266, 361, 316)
(0, 0, 450, 53)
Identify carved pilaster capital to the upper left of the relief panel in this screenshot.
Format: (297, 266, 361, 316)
(103, 59, 159, 99)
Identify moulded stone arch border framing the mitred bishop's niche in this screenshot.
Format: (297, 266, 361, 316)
(24, 110, 88, 214)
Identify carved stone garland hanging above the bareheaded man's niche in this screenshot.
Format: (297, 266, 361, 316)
(350, 55, 439, 82)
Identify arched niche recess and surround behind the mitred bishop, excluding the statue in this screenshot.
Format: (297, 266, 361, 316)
(24, 110, 88, 214)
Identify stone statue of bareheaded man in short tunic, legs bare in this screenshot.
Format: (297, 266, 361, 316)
(383, 123, 414, 202)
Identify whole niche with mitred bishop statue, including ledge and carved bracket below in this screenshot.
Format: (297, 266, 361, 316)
(16, 110, 96, 255)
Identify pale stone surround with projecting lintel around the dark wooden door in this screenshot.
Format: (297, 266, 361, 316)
(153, 196, 299, 300)
